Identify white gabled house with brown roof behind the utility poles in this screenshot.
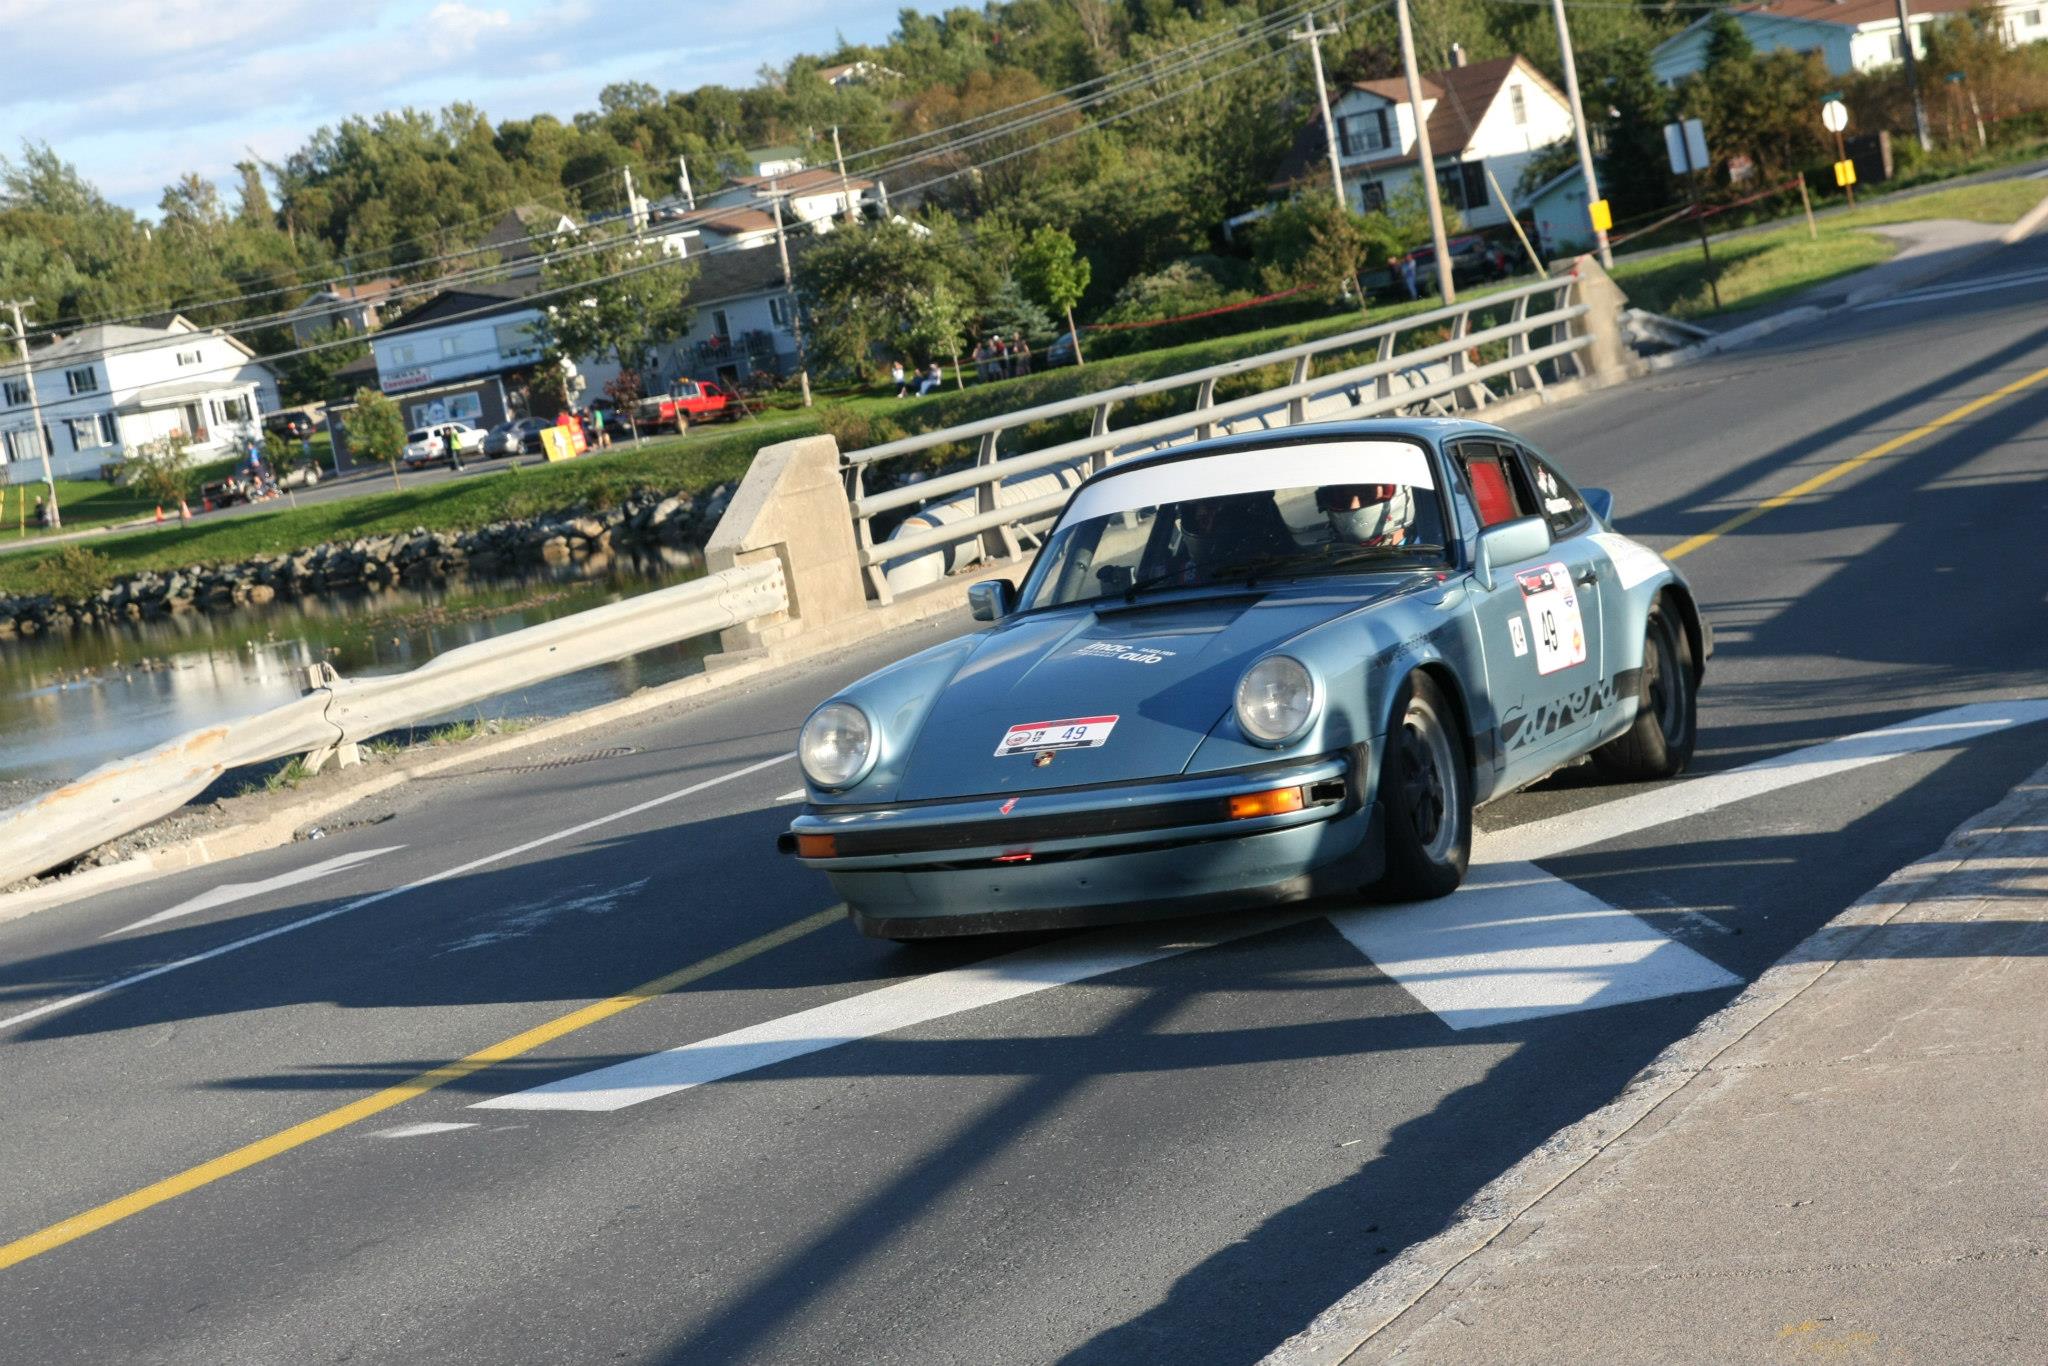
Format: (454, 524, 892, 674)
(1280, 57, 1571, 227)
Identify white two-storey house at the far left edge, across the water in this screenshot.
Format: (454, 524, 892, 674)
(0, 317, 279, 483)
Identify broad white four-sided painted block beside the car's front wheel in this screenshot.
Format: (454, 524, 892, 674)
(1329, 864, 1743, 1030)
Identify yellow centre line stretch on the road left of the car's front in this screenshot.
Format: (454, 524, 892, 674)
(0, 905, 846, 1272)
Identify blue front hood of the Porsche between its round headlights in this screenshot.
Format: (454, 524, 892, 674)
(895, 578, 1411, 801)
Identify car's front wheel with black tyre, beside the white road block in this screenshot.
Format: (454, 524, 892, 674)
(1378, 674, 1473, 901)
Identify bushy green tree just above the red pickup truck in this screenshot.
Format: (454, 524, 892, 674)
(537, 227, 696, 393)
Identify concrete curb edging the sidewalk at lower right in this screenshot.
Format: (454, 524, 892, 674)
(1262, 768, 2048, 1366)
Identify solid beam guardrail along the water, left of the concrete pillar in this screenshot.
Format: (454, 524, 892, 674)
(0, 559, 788, 887)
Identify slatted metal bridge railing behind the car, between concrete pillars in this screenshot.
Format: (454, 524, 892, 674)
(842, 274, 1591, 602)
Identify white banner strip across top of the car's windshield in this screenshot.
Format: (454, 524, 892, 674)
(1059, 440, 1436, 526)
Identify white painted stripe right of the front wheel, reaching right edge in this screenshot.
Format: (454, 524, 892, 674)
(1485, 698, 2048, 862)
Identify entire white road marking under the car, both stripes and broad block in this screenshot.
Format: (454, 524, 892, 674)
(471, 698, 2048, 1110)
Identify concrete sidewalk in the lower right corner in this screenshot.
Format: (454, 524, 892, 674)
(1280, 768, 2048, 1364)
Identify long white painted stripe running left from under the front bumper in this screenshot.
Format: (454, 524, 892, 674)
(469, 911, 1313, 1110)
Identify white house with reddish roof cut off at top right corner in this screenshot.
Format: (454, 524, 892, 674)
(1651, 0, 2048, 84)
